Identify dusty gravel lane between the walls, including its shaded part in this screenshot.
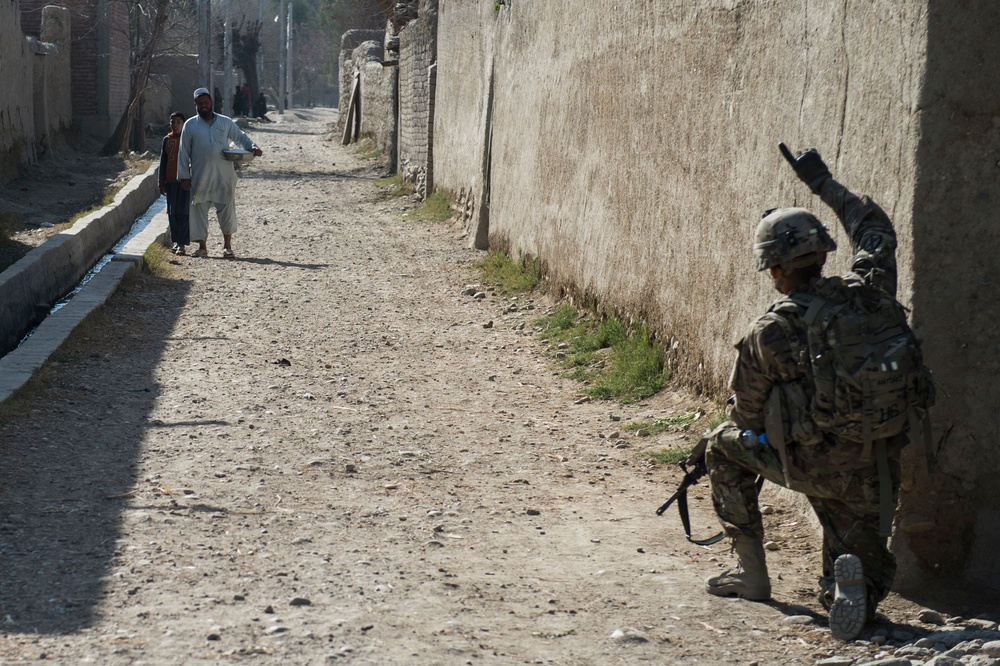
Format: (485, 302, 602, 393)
(0, 109, 972, 665)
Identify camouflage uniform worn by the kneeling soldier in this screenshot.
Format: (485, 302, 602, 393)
(706, 178, 906, 612)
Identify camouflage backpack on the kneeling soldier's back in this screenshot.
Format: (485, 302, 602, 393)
(768, 275, 934, 536)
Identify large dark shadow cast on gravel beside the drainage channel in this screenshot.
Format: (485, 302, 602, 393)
(0, 274, 193, 634)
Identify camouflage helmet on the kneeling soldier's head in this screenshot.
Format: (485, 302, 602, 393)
(753, 208, 837, 271)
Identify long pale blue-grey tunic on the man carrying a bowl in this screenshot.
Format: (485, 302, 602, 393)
(177, 113, 254, 204)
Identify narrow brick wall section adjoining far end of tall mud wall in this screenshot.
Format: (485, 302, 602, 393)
(399, 0, 438, 195)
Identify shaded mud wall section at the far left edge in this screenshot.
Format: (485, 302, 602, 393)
(0, 0, 35, 181)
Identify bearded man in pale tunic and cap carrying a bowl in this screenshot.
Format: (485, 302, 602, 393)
(177, 88, 263, 259)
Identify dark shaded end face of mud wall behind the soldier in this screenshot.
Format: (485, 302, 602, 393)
(893, 0, 1000, 603)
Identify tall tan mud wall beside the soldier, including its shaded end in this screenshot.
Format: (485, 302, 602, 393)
(434, 0, 1000, 588)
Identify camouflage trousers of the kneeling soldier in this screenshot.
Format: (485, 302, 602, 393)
(705, 425, 899, 601)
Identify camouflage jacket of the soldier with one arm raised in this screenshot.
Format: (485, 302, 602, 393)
(729, 179, 896, 444)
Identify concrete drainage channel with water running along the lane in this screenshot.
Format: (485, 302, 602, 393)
(0, 165, 167, 401)
